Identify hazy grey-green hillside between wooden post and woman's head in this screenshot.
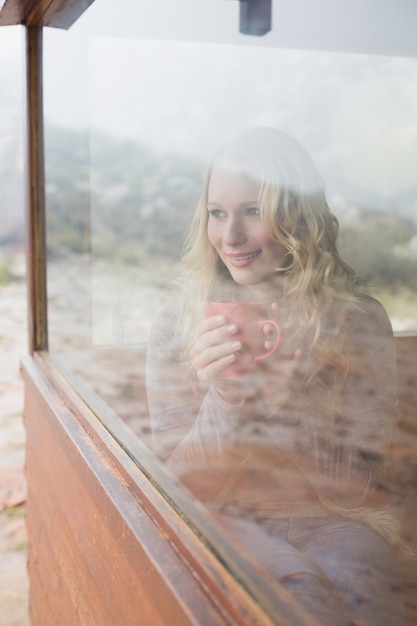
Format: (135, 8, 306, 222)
(46, 127, 203, 262)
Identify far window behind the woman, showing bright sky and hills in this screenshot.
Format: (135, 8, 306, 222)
(88, 37, 417, 336)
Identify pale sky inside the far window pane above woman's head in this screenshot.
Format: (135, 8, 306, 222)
(83, 38, 417, 196)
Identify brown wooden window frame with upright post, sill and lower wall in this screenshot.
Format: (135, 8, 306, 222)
(18, 9, 315, 626)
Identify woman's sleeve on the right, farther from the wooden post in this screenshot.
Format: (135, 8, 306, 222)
(286, 298, 396, 508)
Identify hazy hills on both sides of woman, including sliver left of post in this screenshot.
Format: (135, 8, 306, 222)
(0, 117, 417, 290)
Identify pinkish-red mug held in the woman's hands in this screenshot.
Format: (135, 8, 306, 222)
(208, 302, 282, 378)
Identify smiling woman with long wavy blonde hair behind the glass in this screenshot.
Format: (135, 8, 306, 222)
(147, 129, 402, 626)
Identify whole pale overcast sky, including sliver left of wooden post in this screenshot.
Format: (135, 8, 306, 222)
(0, 0, 417, 210)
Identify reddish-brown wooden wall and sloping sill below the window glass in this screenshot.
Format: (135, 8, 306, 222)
(22, 354, 308, 626)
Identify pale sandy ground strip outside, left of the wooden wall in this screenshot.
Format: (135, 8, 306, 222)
(0, 280, 29, 626)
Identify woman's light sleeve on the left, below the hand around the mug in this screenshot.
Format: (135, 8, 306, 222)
(146, 308, 240, 463)
